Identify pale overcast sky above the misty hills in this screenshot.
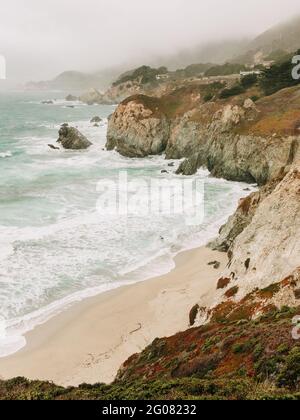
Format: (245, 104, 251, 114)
(0, 0, 300, 81)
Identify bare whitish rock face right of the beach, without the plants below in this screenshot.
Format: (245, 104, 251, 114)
(212, 168, 300, 307)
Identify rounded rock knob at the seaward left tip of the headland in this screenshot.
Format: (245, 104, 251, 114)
(106, 95, 170, 157)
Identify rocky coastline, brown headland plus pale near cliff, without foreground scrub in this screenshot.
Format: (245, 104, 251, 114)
(107, 77, 300, 323)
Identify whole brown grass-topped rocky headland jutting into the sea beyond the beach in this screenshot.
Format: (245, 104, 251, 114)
(108, 84, 300, 185)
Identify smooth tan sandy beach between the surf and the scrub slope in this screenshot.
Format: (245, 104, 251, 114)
(0, 247, 227, 386)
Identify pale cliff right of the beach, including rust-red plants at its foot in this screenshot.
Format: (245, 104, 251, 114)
(202, 167, 300, 323)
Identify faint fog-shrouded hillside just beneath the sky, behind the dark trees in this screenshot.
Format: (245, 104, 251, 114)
(26, 16, 300, 90)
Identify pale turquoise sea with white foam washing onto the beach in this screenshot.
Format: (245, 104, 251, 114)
(0, 92, 251, 356)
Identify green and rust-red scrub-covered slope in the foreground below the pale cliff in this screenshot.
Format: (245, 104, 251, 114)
(0, 302, 300, 400)
